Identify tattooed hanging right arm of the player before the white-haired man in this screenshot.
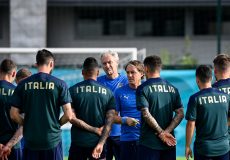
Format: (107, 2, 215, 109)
(98, 109, 115, 145)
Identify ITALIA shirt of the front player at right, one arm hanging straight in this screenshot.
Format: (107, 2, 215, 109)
(186, 88, 230, 156)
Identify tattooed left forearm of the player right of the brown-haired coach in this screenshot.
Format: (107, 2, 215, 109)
(141, 108, 163, 134)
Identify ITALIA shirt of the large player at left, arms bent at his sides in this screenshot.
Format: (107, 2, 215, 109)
(11, 72, 70, 149)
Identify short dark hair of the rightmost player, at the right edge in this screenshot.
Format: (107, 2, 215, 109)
(213, 54, 230, 72)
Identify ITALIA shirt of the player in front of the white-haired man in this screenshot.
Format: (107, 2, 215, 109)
(70, 79, 115, 147)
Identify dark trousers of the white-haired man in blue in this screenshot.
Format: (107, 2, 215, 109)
(106, 136, 120, 160)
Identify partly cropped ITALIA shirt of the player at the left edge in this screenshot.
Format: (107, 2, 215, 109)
(0, 80, 18, 144)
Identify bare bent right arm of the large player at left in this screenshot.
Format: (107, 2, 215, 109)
(59, 103, 73, 126)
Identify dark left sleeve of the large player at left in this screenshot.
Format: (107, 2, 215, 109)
(10, 85, 23, 110)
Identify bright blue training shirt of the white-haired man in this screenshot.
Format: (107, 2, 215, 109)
(97, 74, 128, 136)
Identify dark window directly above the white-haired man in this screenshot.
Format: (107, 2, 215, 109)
(76, 8, 126, 37)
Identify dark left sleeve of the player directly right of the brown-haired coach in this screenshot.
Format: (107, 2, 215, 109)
(136, 87, 149, 110)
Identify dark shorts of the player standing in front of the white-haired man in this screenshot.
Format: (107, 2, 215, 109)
(68, 143, 105, 160)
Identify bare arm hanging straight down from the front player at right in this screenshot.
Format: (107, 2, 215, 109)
(185, 120, 195, 159)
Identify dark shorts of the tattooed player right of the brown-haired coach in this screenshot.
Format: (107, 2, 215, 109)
(138, 145, 176, 160)
